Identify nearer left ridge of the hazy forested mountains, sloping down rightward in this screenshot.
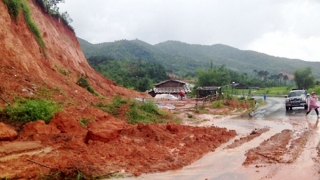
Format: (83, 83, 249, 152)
(79, 39, 201, 76)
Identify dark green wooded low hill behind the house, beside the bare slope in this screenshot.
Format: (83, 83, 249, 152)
(88, 56, 169, 92)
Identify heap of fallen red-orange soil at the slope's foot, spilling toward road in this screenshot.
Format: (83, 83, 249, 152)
(0, 104, 236, 179)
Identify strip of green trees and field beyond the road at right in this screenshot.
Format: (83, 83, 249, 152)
(191, 65, 320, 97)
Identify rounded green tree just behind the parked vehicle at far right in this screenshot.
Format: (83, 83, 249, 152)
(293, 67, 315, 89)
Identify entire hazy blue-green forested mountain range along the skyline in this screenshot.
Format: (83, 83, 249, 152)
(79, 38, 320, 79)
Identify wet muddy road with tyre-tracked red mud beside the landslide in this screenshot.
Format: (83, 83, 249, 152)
(124, 98, 320, 180)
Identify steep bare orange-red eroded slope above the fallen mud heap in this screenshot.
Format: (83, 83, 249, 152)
(0, 1, 146, 100)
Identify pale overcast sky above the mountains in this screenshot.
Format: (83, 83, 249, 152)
(59, 0, 320, 61)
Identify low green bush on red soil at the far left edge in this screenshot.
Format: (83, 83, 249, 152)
(2, 99, 59, 123)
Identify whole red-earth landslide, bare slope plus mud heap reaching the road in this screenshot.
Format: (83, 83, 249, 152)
(0, 0, 236, 179)
